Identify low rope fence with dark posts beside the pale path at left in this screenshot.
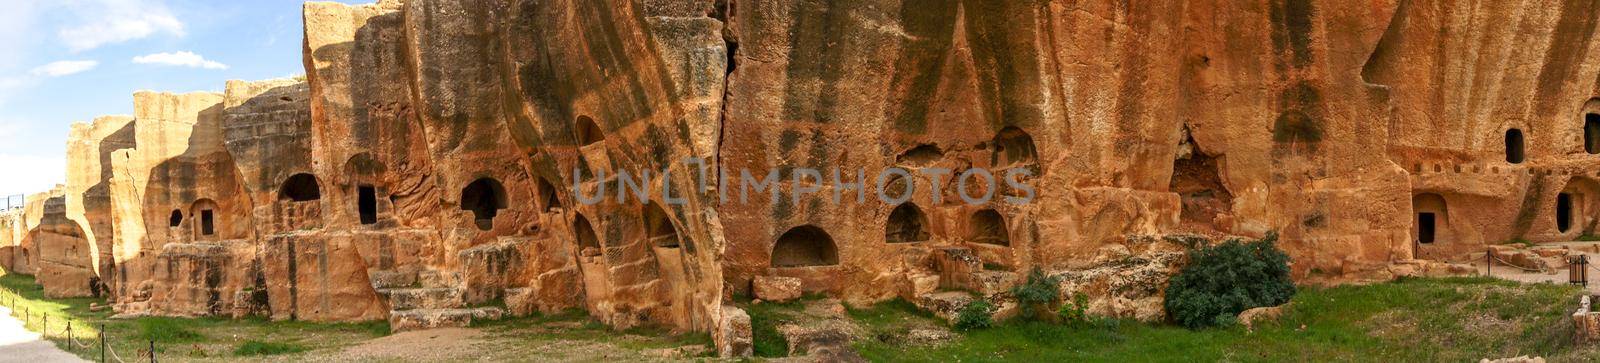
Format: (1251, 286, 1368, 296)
(0, 288, 157, 363)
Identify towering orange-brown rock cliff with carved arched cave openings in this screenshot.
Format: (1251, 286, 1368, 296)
(9, 0, 1600, 355)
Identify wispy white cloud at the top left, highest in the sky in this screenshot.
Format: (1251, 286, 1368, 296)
(58, 0, 184, 51)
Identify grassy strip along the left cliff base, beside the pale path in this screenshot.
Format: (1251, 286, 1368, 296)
(0, 275, 715, 361)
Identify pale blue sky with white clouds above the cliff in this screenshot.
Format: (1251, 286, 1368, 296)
(0, 0, 371, 197)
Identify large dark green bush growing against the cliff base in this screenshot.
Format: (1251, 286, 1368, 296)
(1166, 232, 1294, 329)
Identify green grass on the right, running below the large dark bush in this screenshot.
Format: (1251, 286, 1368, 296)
(851, 278, 1594, 361)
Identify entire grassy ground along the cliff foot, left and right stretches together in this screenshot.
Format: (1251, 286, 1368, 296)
(0, 268, 1600, 361)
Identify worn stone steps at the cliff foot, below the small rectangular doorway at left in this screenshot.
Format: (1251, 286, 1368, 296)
(370, 270, 506, 333)
